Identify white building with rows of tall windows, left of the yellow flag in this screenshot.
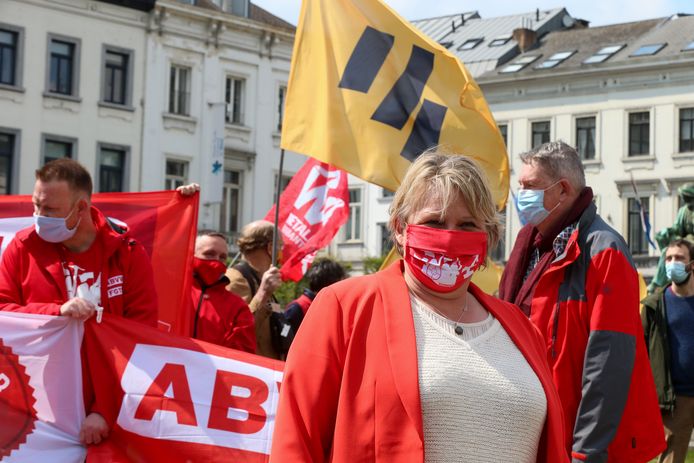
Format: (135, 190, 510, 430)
(0, 0, 305, 245)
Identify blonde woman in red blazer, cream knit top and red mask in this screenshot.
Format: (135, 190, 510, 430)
(270, 152, 568, 463)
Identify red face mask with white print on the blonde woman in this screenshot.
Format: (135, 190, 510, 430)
(405, 225, 487, 293)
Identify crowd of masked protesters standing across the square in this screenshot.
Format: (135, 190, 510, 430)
(0, 142, 694, 463)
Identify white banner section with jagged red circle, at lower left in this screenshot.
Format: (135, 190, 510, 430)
(0, 312, 86, 463)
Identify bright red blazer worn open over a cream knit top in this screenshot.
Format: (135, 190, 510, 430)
(270, 261, 568, 463)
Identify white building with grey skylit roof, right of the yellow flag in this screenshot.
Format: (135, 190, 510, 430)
(477, 15, 694, 277)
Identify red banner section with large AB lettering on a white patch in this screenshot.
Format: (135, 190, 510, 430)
(83, 314, 283, 463)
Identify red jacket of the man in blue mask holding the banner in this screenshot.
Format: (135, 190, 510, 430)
(0, 207, 158, 327)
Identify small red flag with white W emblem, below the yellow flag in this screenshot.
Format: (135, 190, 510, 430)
(265, 158, 349, 281)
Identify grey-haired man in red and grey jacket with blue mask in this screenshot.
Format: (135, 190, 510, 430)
(499, 142, 665, 463)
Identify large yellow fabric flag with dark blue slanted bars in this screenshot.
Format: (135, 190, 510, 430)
(281, 0, 509, 208)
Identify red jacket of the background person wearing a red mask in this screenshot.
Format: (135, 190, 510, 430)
(191, 277, 255, 354)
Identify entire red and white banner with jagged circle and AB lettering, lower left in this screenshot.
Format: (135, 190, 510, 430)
(0, 312, 283, 463)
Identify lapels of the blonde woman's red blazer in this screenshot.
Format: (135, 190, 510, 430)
(380, 259, 554, 442)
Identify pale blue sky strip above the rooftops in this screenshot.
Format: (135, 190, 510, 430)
(251, 0, 694, 26)
